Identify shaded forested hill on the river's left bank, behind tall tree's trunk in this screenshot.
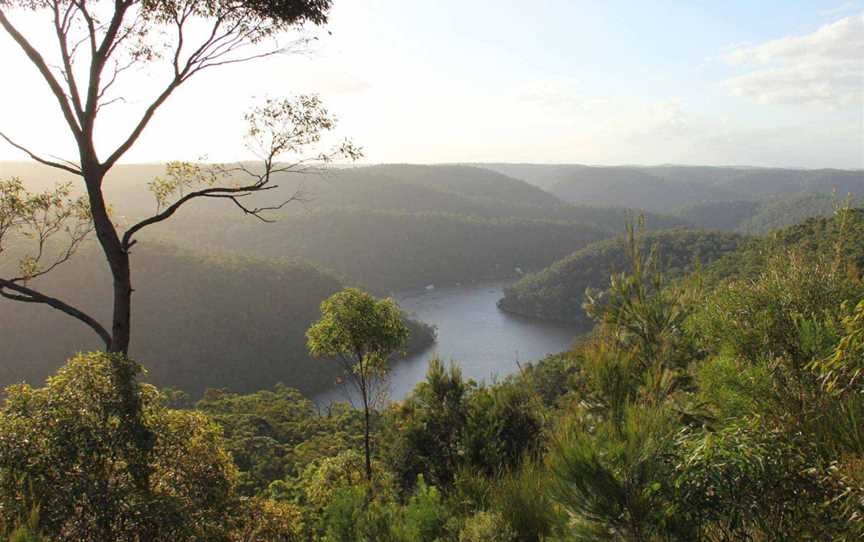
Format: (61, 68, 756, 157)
(0, 241, 432, 396)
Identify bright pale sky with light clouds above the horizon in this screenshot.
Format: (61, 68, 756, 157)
(0, 0, 864, 168)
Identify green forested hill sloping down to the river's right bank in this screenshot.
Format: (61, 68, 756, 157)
(498, 230, 744, 324)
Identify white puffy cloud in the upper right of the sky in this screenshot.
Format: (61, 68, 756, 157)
(720, 13, 864, 107)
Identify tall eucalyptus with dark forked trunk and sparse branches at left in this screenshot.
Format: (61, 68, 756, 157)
(0, 0, 359, 482)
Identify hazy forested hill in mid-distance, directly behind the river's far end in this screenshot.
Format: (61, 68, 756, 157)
(167, 209, 609, 292)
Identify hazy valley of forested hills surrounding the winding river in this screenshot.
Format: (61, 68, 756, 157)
(0, 163, 864, 398)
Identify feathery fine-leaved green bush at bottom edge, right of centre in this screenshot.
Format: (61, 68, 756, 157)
(549, 405, 678, 542)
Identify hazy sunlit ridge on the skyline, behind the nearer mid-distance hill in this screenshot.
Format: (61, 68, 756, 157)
(0, 162, 682, 231)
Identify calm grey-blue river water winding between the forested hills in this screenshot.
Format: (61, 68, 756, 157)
(316, 283, 581, 403)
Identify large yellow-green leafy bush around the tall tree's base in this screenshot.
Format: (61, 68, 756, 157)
(0, 353, 237, 542)
